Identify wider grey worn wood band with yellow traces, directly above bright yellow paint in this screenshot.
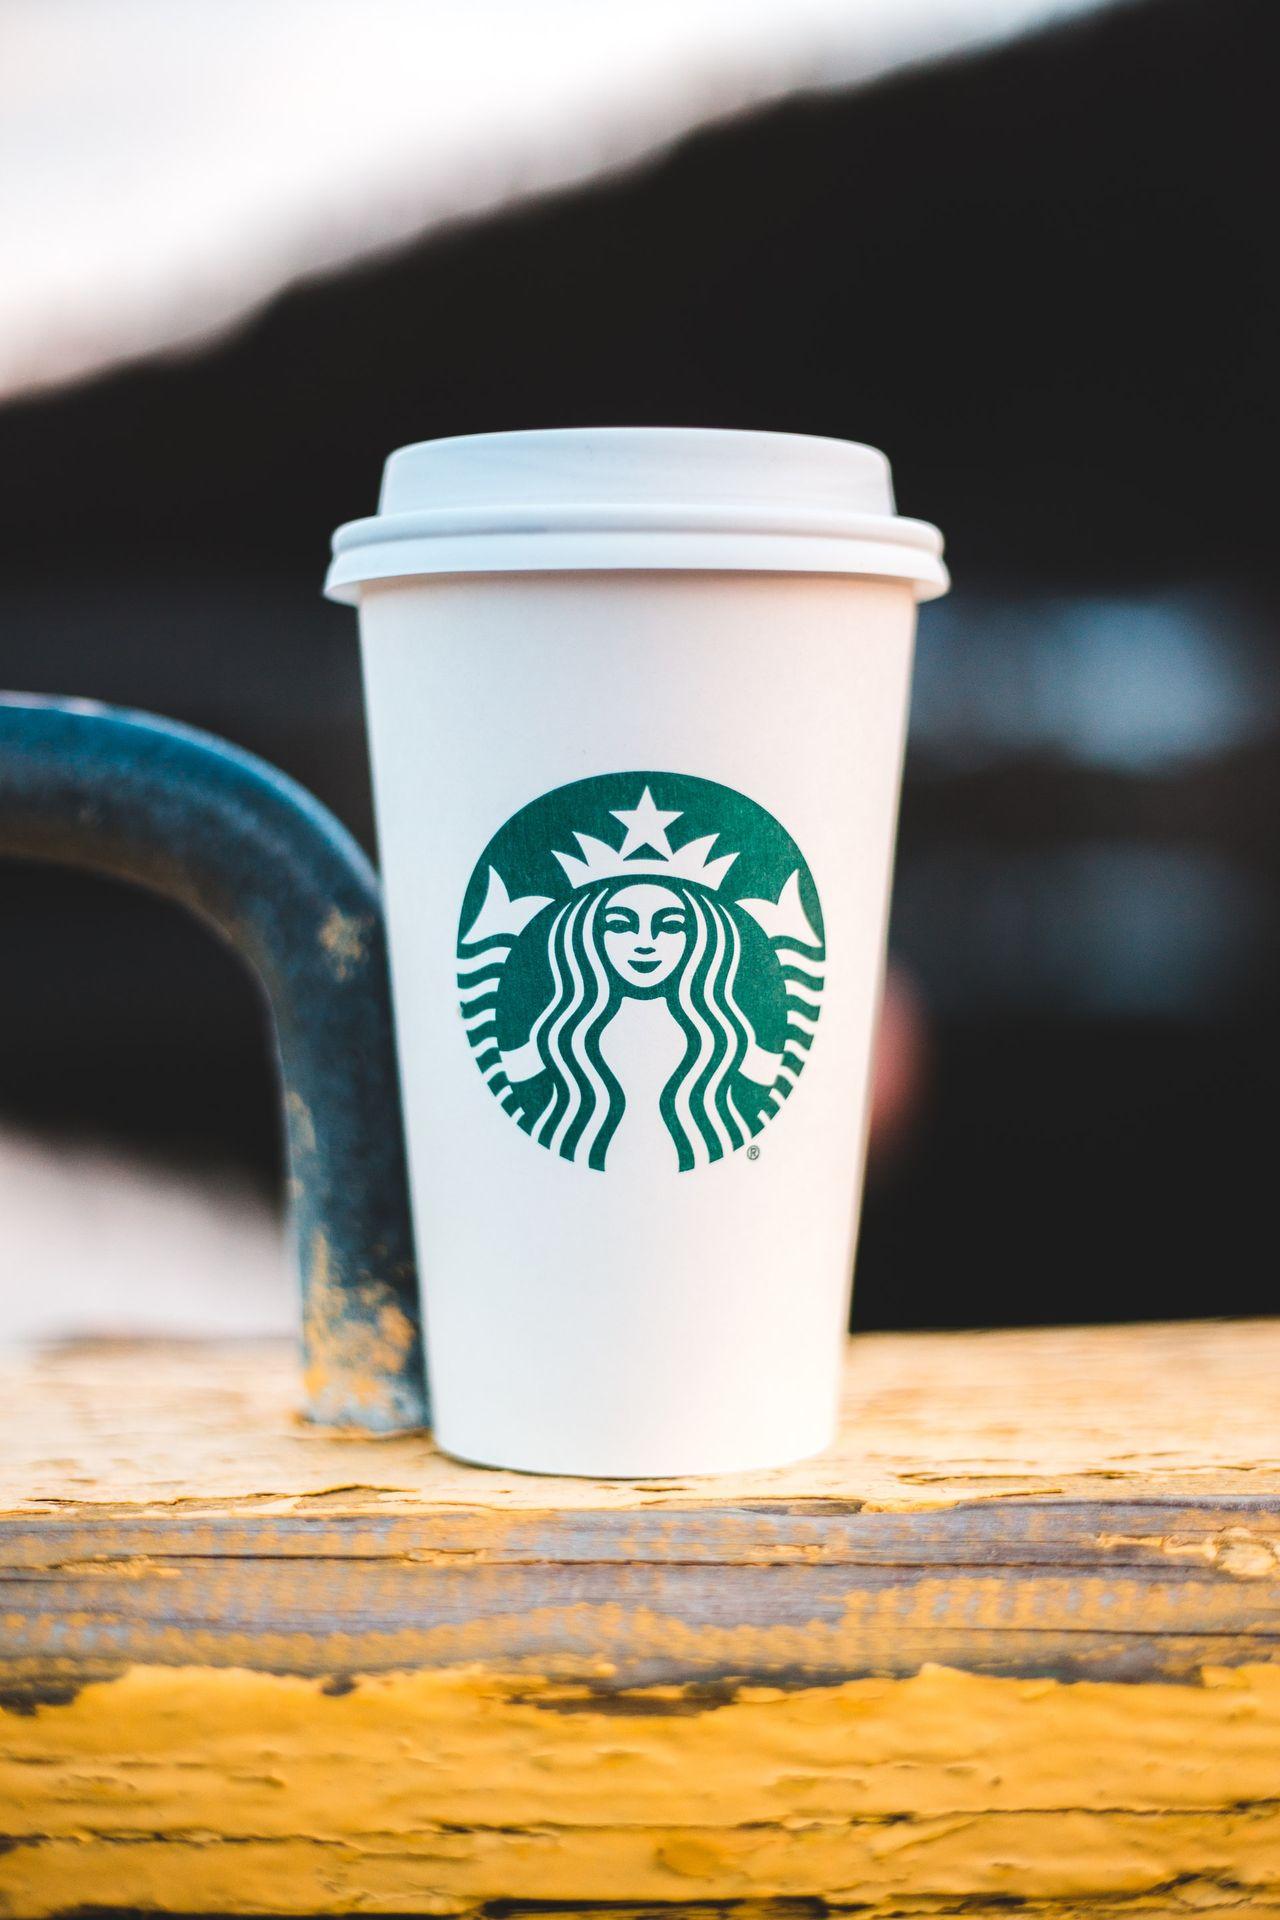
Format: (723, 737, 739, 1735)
(0, 1557, 1280, 1692)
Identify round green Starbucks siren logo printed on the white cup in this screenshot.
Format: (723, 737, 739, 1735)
(459, 772, 827, 1173)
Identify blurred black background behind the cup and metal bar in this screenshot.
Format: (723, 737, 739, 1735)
(0, 0, 1280, 1327)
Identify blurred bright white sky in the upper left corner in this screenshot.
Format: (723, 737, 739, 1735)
(0, 0, 1088, 399)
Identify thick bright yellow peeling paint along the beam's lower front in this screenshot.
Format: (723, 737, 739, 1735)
(0, 1667, 1280, 1916)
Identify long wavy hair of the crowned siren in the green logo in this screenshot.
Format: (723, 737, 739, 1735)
(520, 881, 760, 1173)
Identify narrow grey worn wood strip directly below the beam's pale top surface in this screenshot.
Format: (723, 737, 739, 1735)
(10, 1490, 1280, 1580)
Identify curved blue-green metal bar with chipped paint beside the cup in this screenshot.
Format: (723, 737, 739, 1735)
(0, 693, 428, 1432)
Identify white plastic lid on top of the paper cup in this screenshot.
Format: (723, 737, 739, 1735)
(324, 426, 950, 605)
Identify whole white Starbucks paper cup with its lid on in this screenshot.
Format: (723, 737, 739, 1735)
(326, 428, 946, 1478)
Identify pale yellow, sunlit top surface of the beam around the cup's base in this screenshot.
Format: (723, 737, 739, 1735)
(10, 1320, 1280, 1512)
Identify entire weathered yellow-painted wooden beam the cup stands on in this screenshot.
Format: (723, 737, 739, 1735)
(0, 1323, 1280, 1916)
